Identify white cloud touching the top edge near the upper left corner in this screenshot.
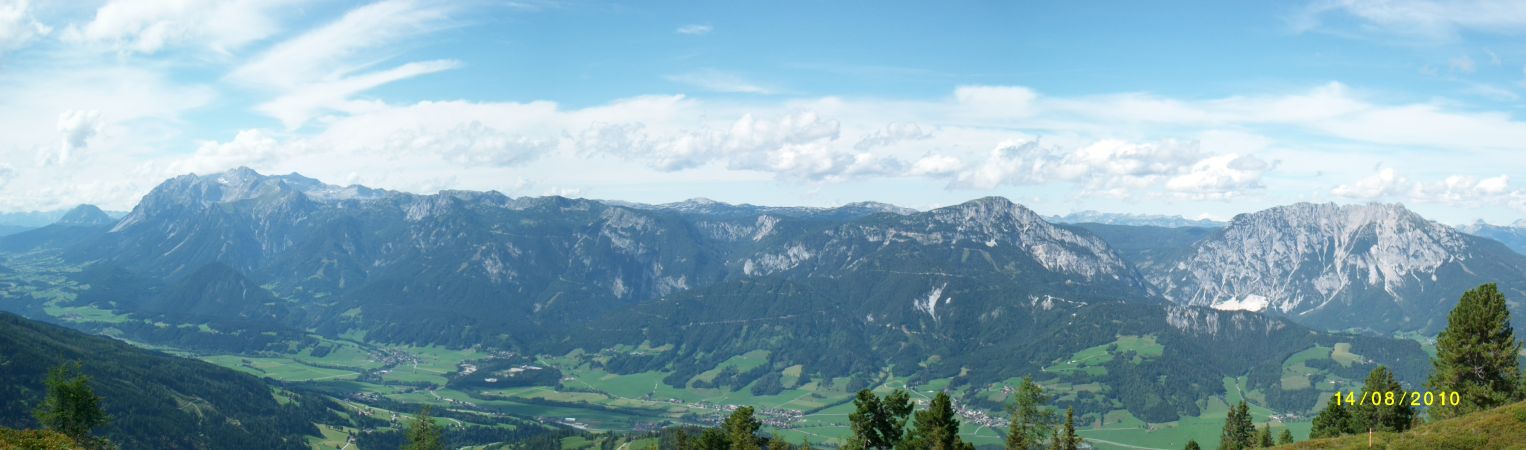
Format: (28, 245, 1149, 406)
(63, 0, 296, 55)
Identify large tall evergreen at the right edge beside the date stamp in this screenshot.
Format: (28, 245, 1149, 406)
(1425, 284, 1521, 418)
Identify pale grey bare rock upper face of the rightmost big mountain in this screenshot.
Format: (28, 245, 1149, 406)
(1149, 203, 1468, 313)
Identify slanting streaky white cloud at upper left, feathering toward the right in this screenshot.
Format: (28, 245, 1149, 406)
(229, 0, 459, 130)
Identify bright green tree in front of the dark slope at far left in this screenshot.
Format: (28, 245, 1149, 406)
(34, 363, 111, 447)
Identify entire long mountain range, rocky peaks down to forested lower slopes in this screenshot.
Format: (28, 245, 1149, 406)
(0, 168, 1526, 421)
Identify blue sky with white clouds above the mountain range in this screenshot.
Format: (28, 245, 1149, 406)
(0, 0, 1526, 224)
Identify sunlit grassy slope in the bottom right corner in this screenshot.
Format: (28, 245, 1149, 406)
(1279, 403, 1526, 450)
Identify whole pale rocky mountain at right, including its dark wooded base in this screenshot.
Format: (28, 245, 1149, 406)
(1148, 203, 1526, 331)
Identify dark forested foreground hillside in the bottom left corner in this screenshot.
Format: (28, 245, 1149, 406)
(0, 313, 327, 448)
